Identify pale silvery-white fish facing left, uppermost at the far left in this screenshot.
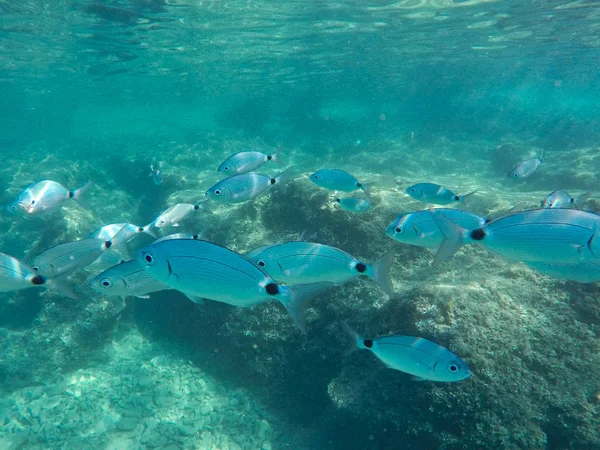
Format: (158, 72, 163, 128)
(7, 180, 92, 216)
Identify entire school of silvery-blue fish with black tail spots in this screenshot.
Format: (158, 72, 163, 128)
(0, 148, 600, 382)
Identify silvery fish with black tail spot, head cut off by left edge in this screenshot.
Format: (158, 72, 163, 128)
(0, 253, 77, 299)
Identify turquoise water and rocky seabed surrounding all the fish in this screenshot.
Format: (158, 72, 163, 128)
(0, 0, 600, 450)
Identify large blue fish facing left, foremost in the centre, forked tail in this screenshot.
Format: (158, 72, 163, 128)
(137, 239, 331, 331)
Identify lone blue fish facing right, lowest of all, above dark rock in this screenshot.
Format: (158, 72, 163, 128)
(342, 322, 471, 382)
